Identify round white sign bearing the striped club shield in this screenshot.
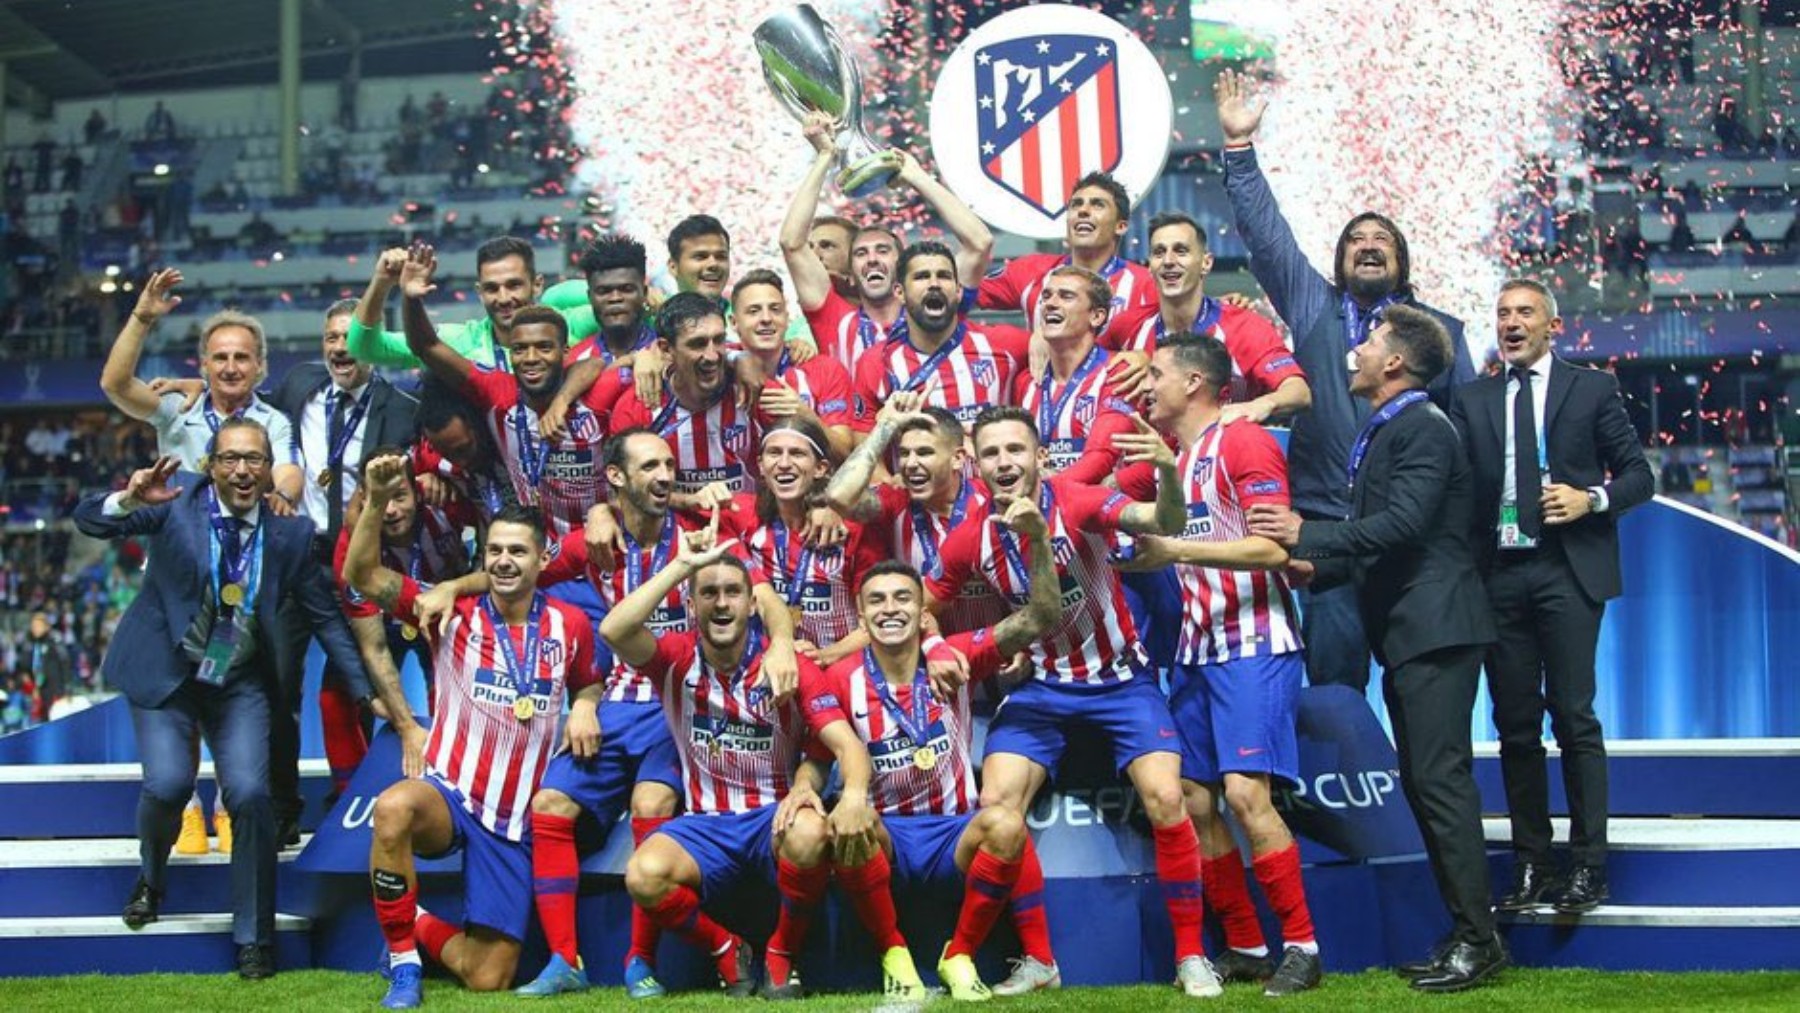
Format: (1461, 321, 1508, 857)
(931, 4, 1174, 239)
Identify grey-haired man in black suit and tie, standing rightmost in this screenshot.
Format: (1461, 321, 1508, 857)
(1451, 279, 1656, 914)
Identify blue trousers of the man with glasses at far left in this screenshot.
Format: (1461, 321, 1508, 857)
(131, 675, 277, 945)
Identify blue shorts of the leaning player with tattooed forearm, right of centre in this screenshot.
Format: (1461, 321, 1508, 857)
(986, 675, 1181, 777)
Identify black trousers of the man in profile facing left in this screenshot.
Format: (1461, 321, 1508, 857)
(1381, 646, 1494, 943)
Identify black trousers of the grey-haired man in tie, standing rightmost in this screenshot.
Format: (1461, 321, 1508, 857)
(1487, 545, 1607, 865)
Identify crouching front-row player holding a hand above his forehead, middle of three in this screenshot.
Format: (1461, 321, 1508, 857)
(599, 525, 856, 997)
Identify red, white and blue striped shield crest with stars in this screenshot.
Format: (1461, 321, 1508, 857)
(976, 34, 1121, 218)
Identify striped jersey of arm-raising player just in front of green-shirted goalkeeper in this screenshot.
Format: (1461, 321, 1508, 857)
(468, 367, 607, 536)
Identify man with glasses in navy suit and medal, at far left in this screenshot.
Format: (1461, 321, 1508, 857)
(76, 417, 376, 979)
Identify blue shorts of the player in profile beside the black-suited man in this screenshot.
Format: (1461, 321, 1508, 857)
(1168, 651, 1307, 784)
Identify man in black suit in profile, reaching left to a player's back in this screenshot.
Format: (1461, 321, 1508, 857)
(1249, 306, 1507, 991)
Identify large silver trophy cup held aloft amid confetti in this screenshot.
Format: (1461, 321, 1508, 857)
(756, 4, 898, 196)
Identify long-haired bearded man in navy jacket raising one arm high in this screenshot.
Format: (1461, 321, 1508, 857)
(1213, 70, 1474, 693)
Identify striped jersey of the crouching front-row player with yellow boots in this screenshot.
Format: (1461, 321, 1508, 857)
(799, 630, 1006, 817)
